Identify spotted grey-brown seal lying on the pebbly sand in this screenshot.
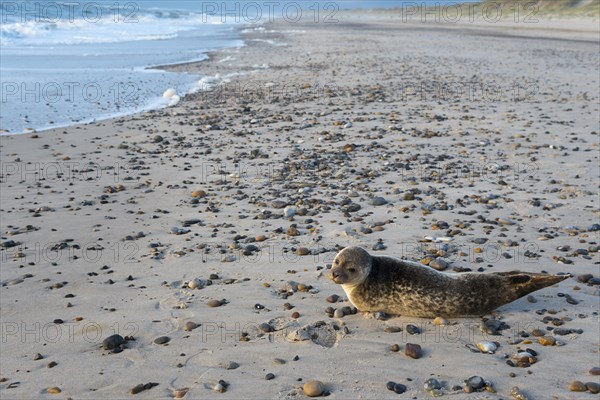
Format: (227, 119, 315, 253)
(329, 247, 568, 318)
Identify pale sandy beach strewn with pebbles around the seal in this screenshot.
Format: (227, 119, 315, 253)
(0, 6, 600, 400)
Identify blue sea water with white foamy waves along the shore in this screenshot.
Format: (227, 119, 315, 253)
(0, 0, 478, 134)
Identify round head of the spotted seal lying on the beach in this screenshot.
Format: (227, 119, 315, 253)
(329, 247, 372, 286)
